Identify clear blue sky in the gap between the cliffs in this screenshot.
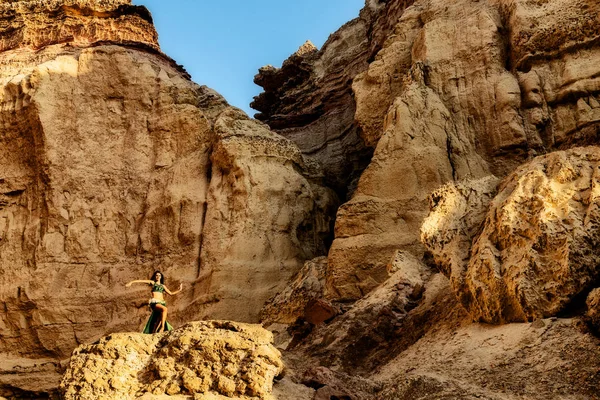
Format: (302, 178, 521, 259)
(133, 0, 364, 116)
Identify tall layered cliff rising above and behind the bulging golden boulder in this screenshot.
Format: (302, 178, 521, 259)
(259, 0, 600, 301)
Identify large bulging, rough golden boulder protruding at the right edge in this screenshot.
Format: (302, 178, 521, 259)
(423, 147, 600, 323)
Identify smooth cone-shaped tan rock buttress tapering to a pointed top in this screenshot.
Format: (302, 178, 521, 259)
(327, 79, 488, 300)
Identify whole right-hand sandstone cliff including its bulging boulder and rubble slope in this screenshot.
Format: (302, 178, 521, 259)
(254, 0, 600, 399)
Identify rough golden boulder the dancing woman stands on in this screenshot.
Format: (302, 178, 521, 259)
(60, 321, 284, 400)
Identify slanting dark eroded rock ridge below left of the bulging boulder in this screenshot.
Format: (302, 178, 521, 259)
(296, 253, 450, 376)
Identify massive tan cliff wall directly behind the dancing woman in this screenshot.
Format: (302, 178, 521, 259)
(0, 1, 335, 374)
